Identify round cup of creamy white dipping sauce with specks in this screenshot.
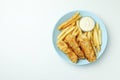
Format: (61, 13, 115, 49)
(80, 17, 95, 31)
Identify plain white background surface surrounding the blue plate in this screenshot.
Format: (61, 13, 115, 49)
(0, 0, 120, 80)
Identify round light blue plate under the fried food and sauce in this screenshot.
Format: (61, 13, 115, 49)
(52, 11, 107, 65)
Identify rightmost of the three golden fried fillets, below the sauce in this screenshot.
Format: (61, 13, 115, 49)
(77, 34, 96, 62)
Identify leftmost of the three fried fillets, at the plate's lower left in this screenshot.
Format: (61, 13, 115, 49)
(57, 41, 78, 63)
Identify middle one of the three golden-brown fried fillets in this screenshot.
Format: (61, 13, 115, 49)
(65, 34, 85, 59)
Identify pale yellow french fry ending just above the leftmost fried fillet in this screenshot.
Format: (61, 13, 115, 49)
(57, 26, 75, 40)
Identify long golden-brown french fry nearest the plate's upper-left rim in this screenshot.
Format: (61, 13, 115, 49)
(58, 12, 81, 30)
